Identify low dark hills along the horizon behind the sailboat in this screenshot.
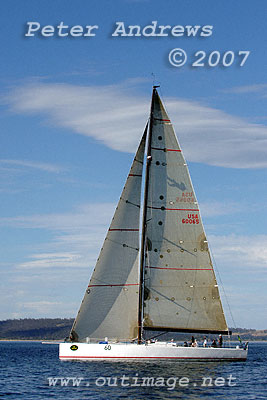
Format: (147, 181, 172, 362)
(0, 318, 267, 341)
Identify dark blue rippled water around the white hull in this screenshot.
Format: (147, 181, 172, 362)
(0, 342, 267, 400)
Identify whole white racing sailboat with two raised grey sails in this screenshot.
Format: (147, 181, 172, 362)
(59, 86, 248, 361)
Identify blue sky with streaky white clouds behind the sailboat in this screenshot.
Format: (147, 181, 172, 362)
(0, 0, 267, 329)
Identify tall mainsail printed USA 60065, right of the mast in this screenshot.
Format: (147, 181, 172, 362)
(143, 89, 228, 332)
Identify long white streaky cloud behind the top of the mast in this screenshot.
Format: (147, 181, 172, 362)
(4, 82, 267, 168)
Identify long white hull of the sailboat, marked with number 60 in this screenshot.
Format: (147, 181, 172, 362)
(59, 342, 247, 361)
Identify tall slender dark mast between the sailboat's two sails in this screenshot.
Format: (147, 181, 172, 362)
(137, 86, 159, 344)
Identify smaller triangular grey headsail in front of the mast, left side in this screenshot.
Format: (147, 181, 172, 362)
(71, 128, 147, 341)
